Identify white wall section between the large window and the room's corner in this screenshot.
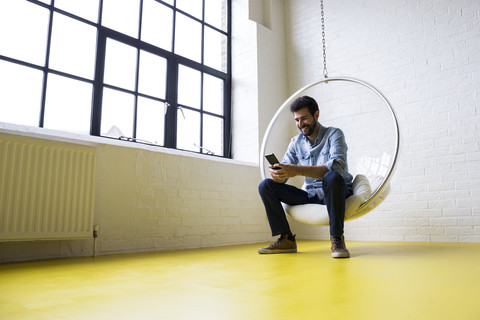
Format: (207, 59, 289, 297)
(232, 0, 288, 163)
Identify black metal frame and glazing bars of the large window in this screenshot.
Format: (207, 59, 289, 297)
(0, 0, 232, 158)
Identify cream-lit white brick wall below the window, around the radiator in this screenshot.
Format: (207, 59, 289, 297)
(0, 133, 270, 262)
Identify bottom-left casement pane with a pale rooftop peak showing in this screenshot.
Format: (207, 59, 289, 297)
(101, 88, 134, 138)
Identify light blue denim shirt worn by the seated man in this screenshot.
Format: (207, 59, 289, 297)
(282, 123, 353, 199)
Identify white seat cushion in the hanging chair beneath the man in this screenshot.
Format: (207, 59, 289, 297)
(282, 174, 372, 226)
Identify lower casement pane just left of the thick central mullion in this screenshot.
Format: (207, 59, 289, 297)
(136, 97, 166, 146)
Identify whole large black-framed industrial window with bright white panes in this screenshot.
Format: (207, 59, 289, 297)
(0, 0, 231, 157)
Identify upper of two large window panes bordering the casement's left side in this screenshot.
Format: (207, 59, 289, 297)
(50, 13, 97, 79)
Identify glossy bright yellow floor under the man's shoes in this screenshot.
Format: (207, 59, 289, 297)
(0, 241, 480, 320)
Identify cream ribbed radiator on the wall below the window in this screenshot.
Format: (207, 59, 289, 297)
(0, 133, 96, 241)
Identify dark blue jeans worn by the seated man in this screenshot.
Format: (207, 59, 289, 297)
(258, 171, 352, 236)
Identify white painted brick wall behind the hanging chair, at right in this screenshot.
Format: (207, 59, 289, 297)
(285, 0, 480, 242)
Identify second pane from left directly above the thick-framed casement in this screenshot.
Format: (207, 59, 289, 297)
(142, 0, 173, 51)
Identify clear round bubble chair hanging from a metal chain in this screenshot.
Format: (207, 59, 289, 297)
(260, 75, 400, 225)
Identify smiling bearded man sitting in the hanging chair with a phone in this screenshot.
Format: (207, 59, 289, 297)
(258, 96, 353, 258)
